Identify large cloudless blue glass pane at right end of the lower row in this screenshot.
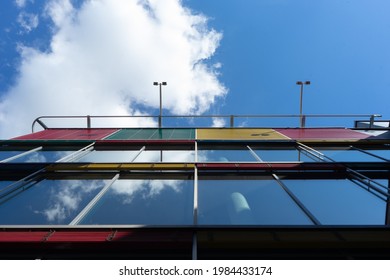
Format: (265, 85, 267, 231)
(284, 180, 386, 225)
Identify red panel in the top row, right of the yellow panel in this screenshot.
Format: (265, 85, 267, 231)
(275, 128, 368, 140)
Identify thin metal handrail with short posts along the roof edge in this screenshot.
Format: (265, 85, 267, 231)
(31, 114, 382, 132)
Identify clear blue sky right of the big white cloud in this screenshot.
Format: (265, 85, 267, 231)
(185, 0, 390, 115)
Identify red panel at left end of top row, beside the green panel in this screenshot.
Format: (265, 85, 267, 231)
(13, 128, 117, 140)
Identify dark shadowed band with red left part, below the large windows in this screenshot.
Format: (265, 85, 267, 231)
(0, 226, 390, 259)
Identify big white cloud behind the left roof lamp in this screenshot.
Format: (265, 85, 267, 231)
(0, 0, 226, 138)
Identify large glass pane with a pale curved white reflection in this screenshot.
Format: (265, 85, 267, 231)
(198, 180, 312, 225)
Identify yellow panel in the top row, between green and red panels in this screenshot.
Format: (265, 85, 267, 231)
(197, 128, 290, 140)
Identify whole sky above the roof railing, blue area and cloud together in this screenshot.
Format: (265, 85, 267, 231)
(0, 0, 390, 138)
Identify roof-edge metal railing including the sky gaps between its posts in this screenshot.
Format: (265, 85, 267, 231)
(31, 114, 382, 132)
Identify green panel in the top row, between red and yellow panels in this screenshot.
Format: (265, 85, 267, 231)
(106, 128, 195, 140)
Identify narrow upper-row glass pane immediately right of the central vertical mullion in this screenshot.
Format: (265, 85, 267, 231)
(198, 148, 258, 162)
